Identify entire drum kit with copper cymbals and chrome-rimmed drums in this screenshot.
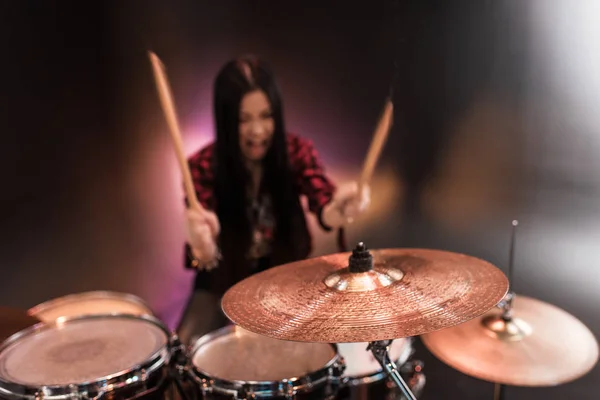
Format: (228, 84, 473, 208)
(0, 231, 598, 400)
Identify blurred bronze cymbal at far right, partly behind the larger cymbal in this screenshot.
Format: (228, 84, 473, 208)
(422, 296, 598, 386)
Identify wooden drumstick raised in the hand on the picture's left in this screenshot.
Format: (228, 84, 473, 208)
(148, 51, 204, 210)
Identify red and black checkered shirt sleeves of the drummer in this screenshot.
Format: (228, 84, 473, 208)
(189, 134, 336, 222)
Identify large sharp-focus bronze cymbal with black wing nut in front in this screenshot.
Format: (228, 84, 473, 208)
(222, 244, 508, 343)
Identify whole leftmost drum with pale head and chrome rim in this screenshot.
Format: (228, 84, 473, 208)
(0, 315, 177, 400)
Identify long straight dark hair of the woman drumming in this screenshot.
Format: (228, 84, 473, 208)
(213, 56, 310, 288)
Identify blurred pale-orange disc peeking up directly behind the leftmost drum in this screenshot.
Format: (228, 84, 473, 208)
(28, 291, 153, 323)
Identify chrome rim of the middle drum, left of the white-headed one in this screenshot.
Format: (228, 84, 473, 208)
(189, 325, 345, 397)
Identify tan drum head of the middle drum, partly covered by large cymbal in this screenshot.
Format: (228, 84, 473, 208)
(191, 326, 336, 382)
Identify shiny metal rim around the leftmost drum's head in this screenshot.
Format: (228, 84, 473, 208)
(0, 313, 174, 399)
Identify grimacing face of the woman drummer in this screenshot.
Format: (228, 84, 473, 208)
(239, 90, 275, 161)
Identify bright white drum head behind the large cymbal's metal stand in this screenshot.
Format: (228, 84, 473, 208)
(338, 338, 411, 378)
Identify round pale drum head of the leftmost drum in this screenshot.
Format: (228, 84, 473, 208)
(0, 316, 168, 387)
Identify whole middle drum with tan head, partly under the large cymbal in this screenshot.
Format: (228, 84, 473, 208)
(190, 325, 344, 400)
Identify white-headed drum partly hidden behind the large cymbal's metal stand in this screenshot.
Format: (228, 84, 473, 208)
(338, 338, 424, 400)
